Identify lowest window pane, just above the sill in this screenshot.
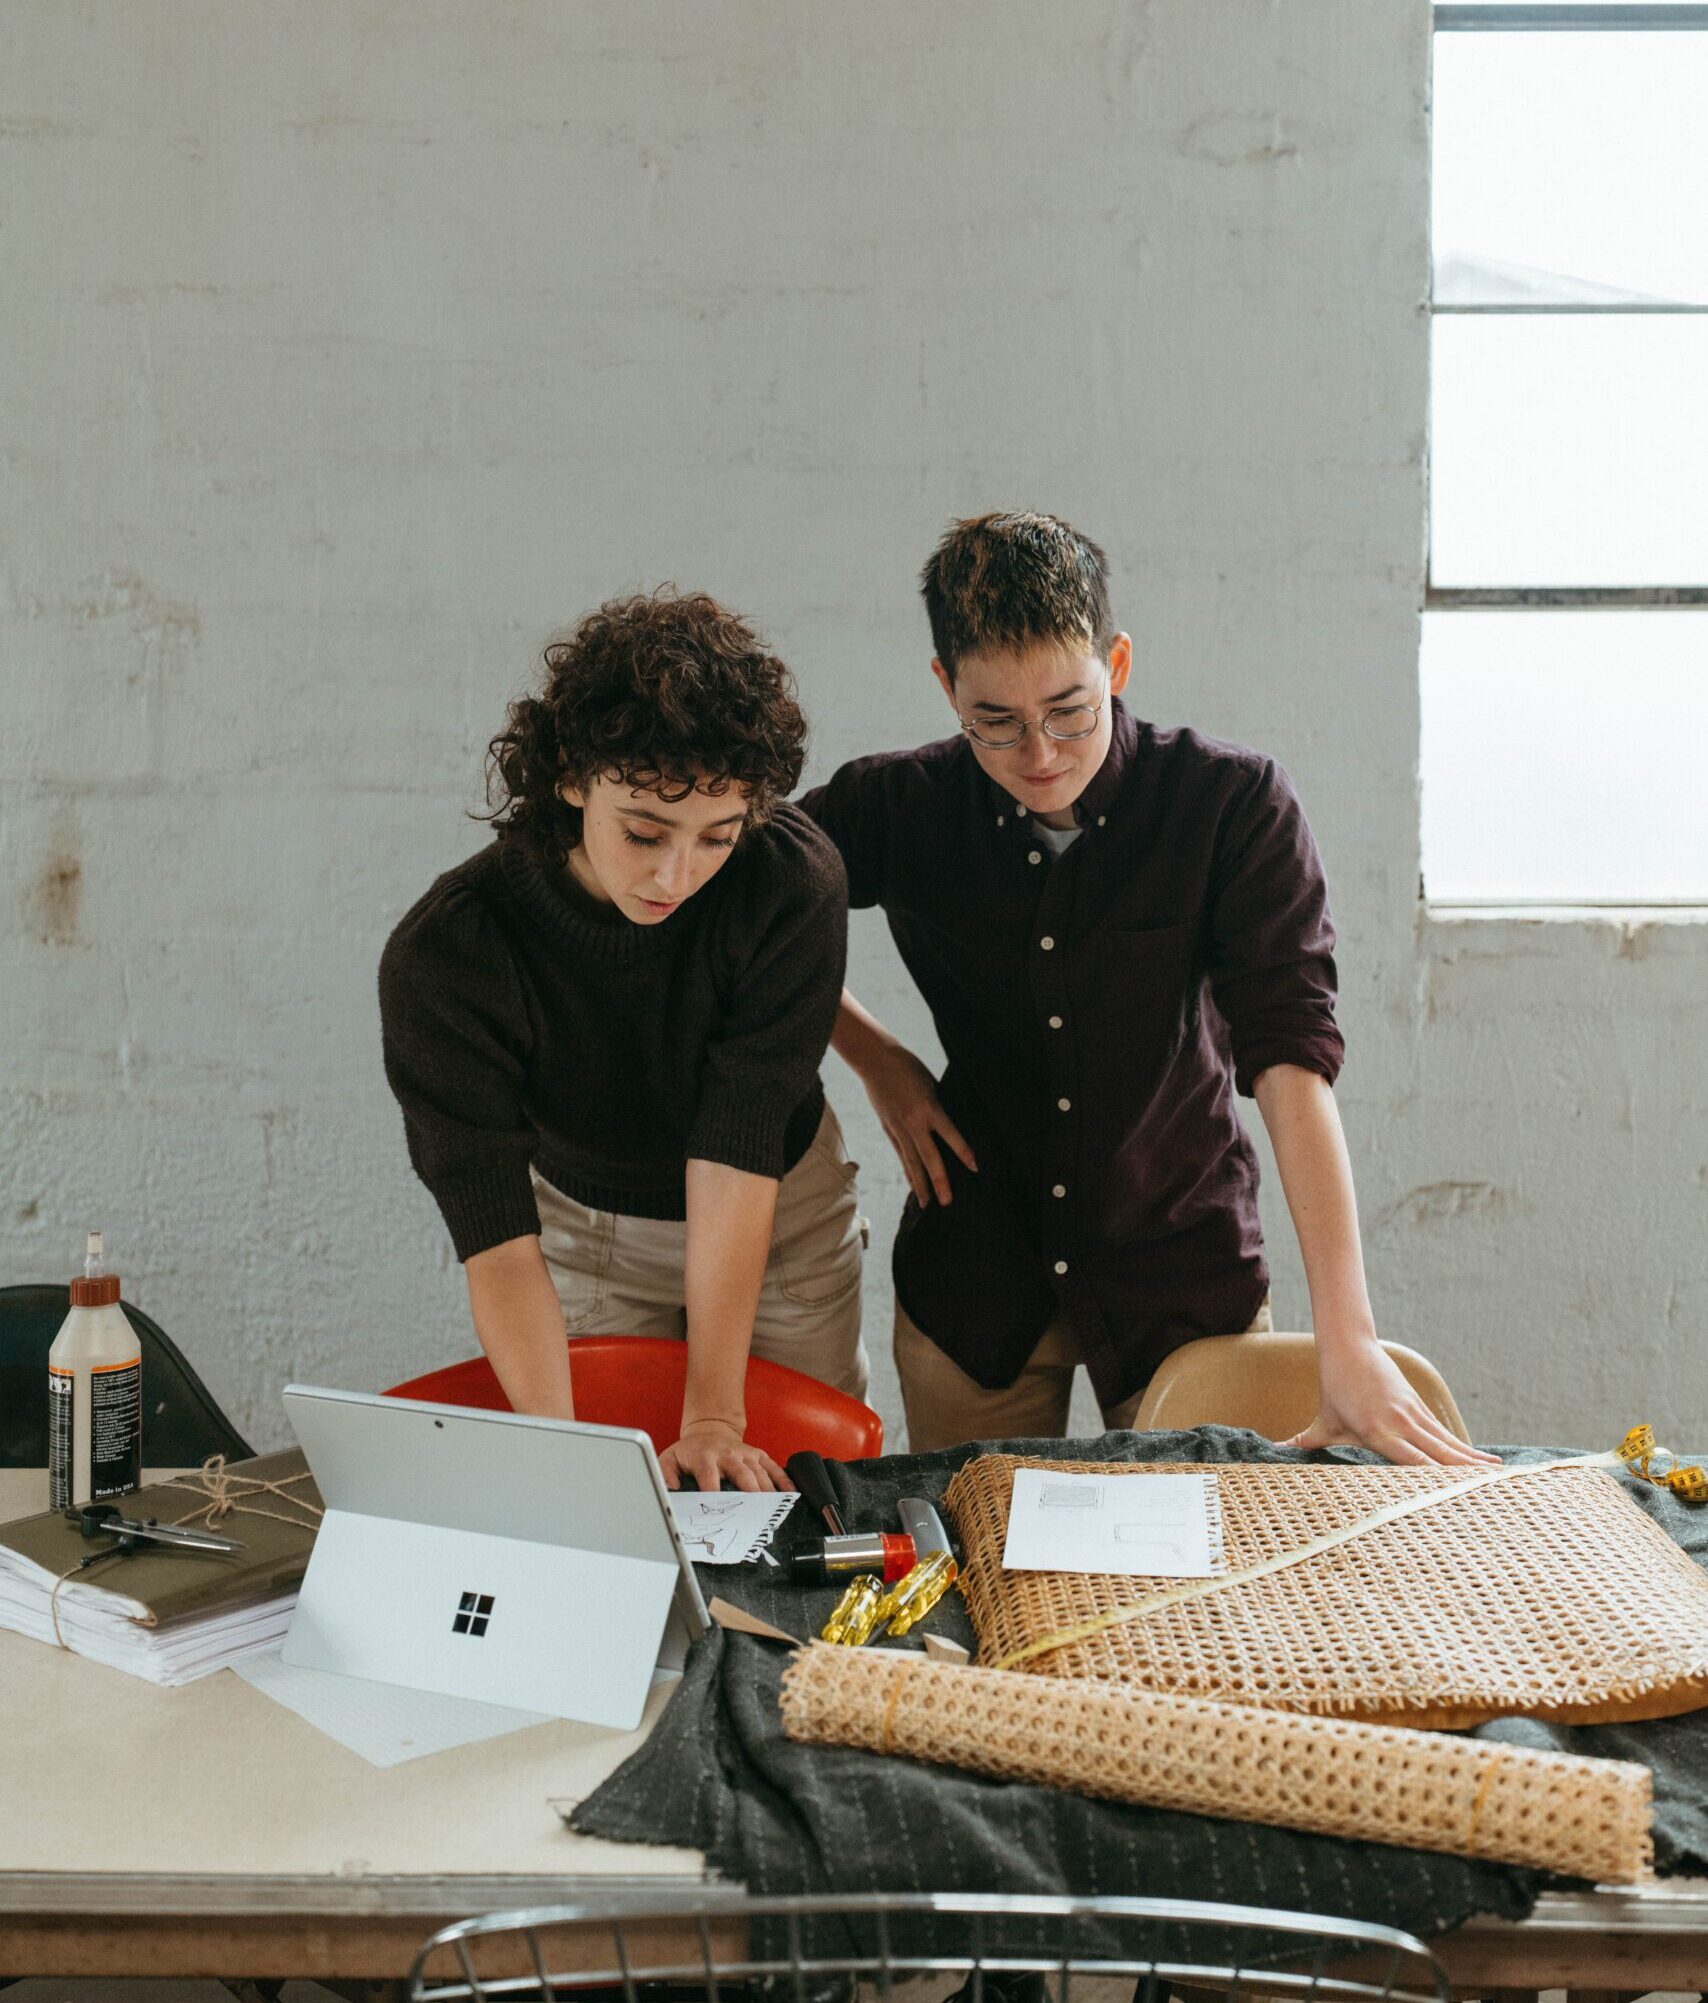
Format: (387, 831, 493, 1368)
(1422, 611, 1708, 903)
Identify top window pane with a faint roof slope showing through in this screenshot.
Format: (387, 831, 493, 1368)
(1434, 32, 1708, 304)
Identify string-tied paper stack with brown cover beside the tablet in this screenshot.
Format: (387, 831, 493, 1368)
(0, 1452, 320, 1685)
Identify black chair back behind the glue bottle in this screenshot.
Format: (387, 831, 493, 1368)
(0, 1286, 254, 1468)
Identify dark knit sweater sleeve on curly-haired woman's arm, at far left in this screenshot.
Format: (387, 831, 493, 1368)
(380, 893, 541, 1260)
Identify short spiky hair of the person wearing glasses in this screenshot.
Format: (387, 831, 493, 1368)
(919, 515, 1113, 681)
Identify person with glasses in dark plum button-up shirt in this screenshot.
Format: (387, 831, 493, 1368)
(801, 513, 1486, 1462)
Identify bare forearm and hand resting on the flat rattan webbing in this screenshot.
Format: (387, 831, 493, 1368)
(1253, 1064, 1496, 1466)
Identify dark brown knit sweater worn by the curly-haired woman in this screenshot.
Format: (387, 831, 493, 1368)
(380, 805, 847, 1260)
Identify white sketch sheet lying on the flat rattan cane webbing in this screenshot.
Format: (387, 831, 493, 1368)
(1003, 1468, 1225, 1578)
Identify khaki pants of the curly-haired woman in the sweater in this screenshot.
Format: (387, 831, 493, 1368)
(535, 1106, 867, 1398)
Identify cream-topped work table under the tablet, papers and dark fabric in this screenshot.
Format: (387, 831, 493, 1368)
(0, 1470, 1708, 1995)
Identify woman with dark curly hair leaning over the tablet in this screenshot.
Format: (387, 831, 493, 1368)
(380, 593, 867, 1488)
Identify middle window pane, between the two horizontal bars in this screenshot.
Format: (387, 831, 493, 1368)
(1430, 314, 1708, 585)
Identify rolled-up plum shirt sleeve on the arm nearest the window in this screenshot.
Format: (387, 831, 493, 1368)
(1207, 759, 1346, 1098)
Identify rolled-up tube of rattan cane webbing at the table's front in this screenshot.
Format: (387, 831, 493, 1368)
(783, 1642, 1652, 1883)
